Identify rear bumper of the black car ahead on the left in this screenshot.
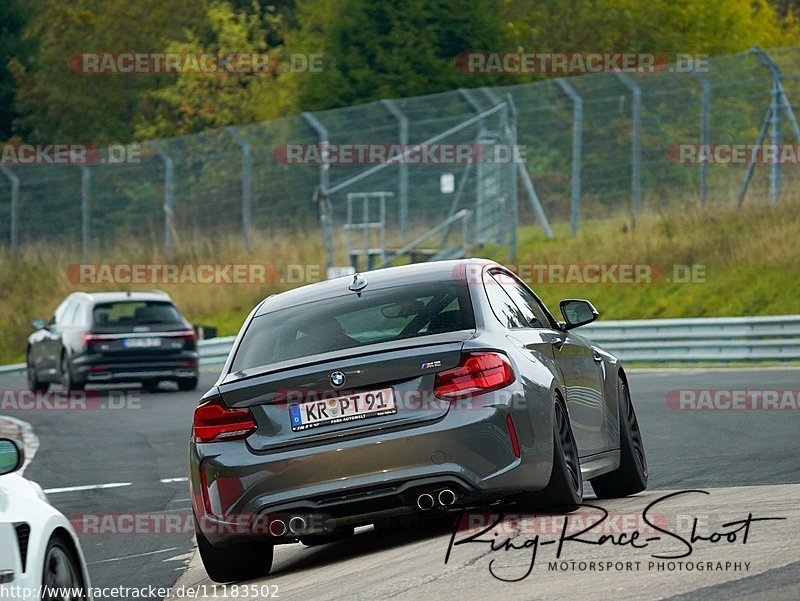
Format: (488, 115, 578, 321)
(72, 351, 198, 384)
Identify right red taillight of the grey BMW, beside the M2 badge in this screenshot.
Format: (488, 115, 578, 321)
(433, 353, 515, 400)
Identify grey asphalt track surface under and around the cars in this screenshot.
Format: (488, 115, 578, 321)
(0, 368, 800, 601)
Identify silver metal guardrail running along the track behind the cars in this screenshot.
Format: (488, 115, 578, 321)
(0, 315, 800, 374)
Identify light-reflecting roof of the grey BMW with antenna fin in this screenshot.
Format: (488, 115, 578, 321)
(256, 259, 497, 316)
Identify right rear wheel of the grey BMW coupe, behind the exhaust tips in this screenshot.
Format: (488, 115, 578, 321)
(520, 398, 583, 513)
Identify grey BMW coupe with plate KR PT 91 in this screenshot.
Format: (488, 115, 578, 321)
(189, 259, 647, 582)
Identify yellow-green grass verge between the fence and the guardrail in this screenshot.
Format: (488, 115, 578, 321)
(0, 202, 800, 364)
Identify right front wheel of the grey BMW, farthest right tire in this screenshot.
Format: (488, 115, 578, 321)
(590, 378, 647, 499)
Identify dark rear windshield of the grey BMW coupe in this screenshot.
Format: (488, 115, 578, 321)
(232, 283, 475, 371)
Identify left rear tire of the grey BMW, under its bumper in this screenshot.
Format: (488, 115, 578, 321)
(195, 529, 275, 582)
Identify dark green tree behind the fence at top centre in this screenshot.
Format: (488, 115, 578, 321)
(287, 0, 504, 110)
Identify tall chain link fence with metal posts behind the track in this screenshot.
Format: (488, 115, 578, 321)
(0, 48, 800, 268)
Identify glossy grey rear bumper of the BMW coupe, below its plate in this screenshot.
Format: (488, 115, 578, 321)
(190, 398, 552, 546)
